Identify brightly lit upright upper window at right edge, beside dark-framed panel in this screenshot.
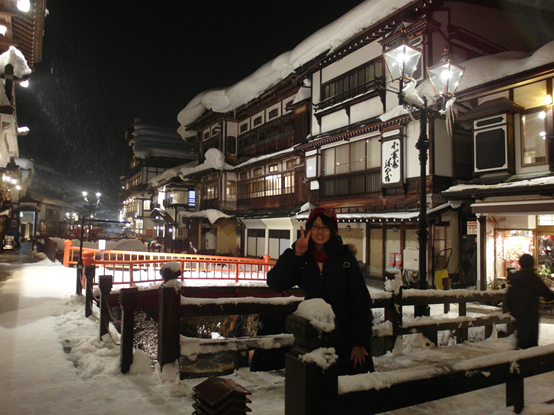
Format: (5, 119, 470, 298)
(521, 110, 547, 166)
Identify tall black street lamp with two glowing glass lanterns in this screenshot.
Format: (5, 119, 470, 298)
(383, 40, 464, 316)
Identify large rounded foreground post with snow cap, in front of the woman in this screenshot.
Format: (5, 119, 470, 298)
(285, 298, 340, 415)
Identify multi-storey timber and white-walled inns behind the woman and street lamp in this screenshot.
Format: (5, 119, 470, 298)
(174, 0, 554, 288)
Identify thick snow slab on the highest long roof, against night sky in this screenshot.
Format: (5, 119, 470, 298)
(177, 0, 414, 137)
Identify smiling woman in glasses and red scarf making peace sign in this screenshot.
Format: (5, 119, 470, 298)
(267, 208, 374, 375)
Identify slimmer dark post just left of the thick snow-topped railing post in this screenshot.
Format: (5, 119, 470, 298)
(119, 287, 138, 373)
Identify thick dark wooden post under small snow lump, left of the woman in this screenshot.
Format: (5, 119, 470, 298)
(158, 285, 181, 370)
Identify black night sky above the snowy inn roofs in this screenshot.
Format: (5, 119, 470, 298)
(16, 0, 361, 201)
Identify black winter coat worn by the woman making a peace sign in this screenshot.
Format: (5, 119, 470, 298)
(267, 235, 372, 361)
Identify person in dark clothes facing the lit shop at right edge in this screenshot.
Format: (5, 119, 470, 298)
(506, 254, 554, 349)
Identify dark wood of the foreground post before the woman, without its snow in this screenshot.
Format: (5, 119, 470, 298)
(285, 314, 340, 415)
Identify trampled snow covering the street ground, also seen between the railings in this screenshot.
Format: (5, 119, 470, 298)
(0, 257, 554, 415)
